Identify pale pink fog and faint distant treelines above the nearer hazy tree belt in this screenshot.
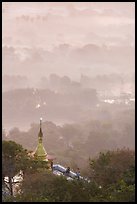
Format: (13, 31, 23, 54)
(2, 2, 135, 140)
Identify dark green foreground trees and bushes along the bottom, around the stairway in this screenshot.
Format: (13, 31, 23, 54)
(2, 141, 135, 202)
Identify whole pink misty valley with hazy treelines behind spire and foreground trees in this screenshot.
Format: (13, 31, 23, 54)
(2, 2, 135, 164)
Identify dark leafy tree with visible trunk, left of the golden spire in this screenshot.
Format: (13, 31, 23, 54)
(2, 141, 48, 199)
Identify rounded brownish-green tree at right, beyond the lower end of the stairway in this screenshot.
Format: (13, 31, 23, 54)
(90, 148, 135, 186)
